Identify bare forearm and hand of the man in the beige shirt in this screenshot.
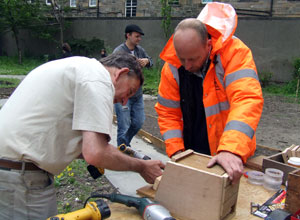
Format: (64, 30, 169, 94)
(82, 131, 165, 183)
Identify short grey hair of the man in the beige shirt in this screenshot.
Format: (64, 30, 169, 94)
(99, 51, 144, 85)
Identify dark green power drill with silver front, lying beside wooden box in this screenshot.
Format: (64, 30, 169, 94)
(91, 193, 176, 220)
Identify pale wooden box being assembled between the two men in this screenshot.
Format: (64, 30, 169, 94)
(155, 150, 239, 220)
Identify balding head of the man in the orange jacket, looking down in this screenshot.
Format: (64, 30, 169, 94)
(174, 18, 212, 72)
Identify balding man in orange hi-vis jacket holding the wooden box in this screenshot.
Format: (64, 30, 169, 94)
(155, 2, 263, 183)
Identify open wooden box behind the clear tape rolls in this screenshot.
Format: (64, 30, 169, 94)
(263, 153, 297, 185)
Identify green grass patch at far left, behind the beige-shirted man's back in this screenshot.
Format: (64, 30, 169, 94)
(0, 56, 44, 75)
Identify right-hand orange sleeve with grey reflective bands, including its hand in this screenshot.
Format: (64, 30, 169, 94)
(208, 39, 263, 183)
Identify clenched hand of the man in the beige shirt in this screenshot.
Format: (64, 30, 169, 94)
(140, 160, 165, 184)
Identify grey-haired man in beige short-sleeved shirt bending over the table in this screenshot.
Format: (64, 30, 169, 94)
(0, 53, 164, 219)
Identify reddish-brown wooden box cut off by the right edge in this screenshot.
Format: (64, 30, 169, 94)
(285, 169, 300, 213)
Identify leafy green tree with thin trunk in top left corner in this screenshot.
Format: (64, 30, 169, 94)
(0, 0, 51, 64)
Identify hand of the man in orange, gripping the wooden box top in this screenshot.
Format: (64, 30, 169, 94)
(207, 151, 244, 184)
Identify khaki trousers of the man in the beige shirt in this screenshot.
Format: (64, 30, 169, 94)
(0, 168, 57, 220)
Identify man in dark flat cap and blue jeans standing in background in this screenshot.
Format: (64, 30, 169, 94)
(113, 24, 153, 146)
